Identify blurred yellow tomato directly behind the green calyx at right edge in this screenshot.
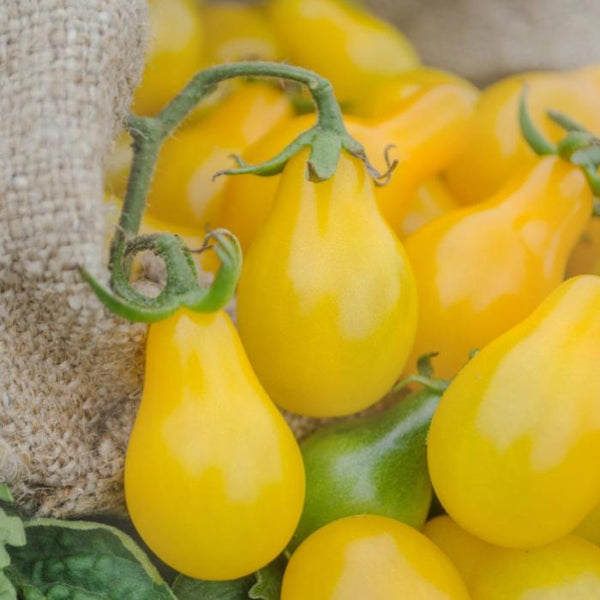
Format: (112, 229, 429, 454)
(445, 72, 600, 204)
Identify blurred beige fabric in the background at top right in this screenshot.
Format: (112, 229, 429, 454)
(366, 0, 600, 84)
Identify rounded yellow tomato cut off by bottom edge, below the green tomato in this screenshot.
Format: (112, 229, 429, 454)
(281, 515, 469, 600)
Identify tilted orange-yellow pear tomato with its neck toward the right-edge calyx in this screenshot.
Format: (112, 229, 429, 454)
(405, 156, 592, 378)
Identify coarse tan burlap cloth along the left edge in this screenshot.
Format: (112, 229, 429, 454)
(0, 0, 146, 515)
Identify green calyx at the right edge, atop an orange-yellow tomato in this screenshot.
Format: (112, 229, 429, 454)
(519, 85, 600, 196)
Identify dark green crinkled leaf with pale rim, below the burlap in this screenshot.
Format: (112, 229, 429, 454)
(7, 519, 175, 600)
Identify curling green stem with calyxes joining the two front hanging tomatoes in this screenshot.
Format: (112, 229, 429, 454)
(81, 61, 384, 323)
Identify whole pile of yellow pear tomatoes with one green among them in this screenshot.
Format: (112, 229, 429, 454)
(107, 0, 600, 600)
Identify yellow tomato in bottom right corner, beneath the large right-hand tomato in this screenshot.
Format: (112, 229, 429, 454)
(423, 517, 600, 600)
